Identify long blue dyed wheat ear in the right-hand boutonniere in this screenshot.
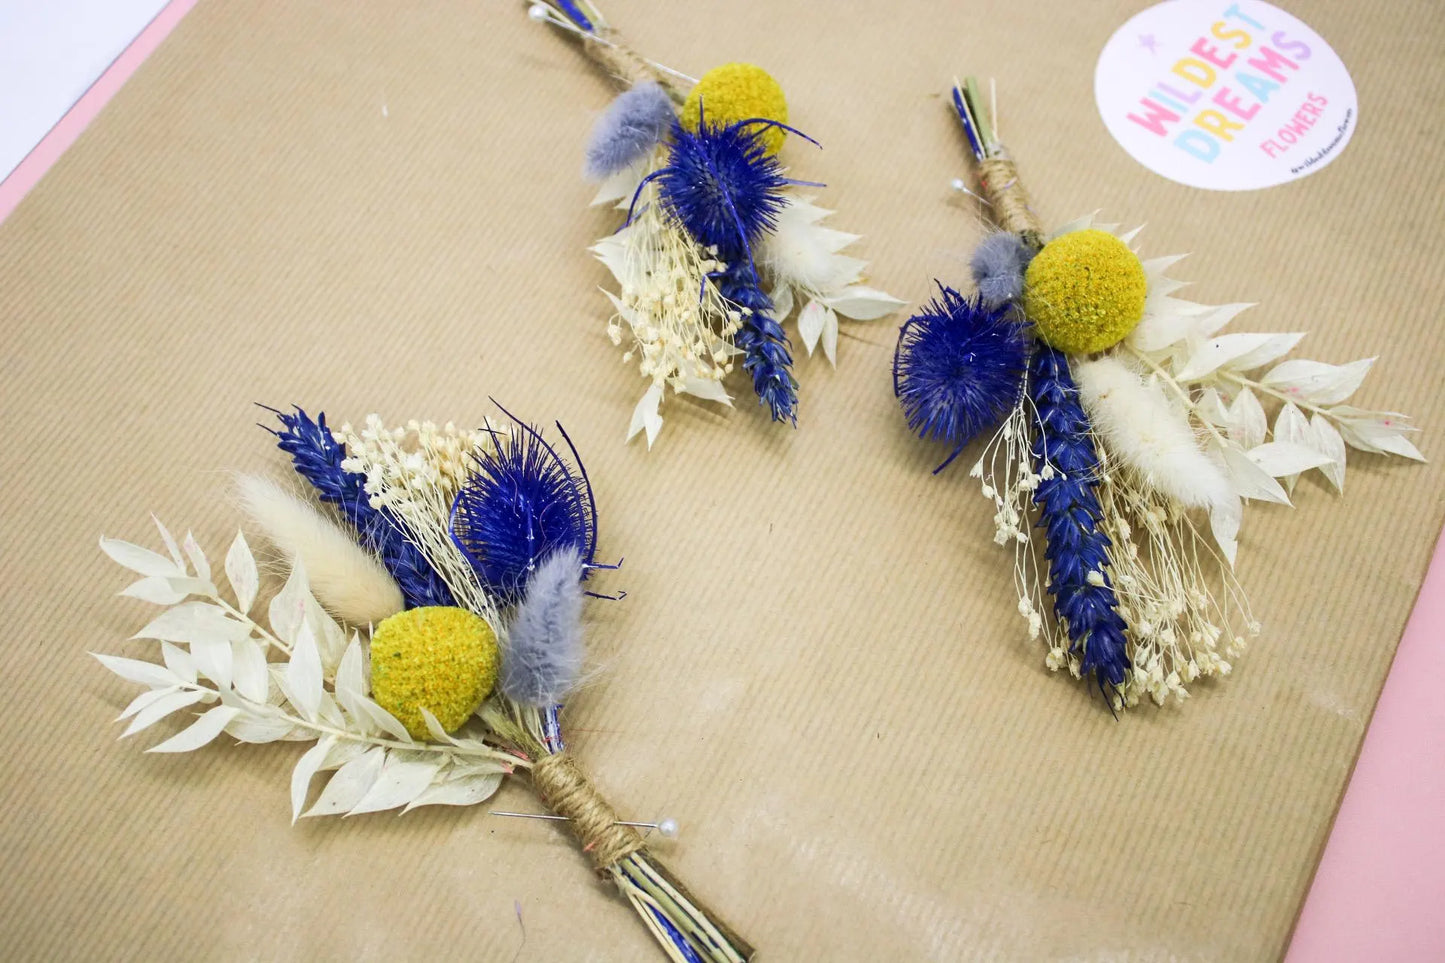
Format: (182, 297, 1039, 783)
(1029, 343, 1130, 700)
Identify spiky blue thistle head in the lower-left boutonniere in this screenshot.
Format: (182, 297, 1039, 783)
(451, 408, 597, 603)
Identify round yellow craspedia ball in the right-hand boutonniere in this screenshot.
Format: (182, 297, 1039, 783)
(1023, 228, 1149, 354)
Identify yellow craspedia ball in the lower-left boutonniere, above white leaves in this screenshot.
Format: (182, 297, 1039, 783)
(371, 606, 499, 739)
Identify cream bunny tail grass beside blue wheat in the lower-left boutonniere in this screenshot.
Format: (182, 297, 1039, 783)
(236, 474, 403, 625)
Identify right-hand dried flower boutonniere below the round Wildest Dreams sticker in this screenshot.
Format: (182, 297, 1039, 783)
(893, 80, 1422, 711)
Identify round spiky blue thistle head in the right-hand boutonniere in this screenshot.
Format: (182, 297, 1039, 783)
(893, 282, 1027, 468)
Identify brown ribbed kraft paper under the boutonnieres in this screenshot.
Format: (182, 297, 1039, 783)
(0, 0, 1445, 960)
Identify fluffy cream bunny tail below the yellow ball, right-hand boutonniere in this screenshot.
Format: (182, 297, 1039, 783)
(1074, 354, 1235, 508)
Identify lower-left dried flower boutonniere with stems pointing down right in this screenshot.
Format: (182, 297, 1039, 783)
(97, 408, 753, 963)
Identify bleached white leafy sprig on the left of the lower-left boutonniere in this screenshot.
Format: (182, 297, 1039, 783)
(95, 521, 514, 820)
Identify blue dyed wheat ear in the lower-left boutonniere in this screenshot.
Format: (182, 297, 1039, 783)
(262, 405, 457, 609)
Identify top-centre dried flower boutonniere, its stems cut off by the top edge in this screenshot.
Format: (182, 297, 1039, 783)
(527, 0, 903, 448)
